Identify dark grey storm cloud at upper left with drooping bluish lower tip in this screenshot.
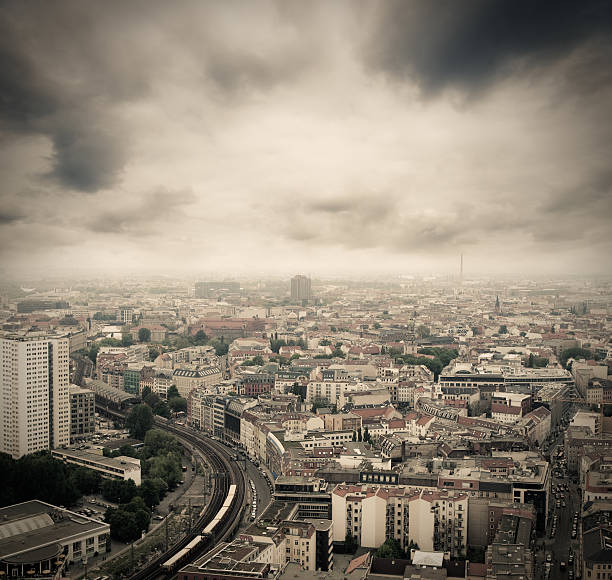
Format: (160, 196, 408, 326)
(0, 3, 133, 192)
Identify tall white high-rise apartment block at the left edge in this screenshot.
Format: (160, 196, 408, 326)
(0, 335, 70, 459)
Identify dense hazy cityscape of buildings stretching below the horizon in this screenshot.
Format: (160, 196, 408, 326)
(0, 274, 612, 580)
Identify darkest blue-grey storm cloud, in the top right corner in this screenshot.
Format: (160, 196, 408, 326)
(365, 0, 612, 92)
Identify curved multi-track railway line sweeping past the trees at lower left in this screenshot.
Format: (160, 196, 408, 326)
(95, 408, 246, 580)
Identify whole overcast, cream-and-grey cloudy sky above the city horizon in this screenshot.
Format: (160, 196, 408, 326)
(0, 0, 612, 276)
